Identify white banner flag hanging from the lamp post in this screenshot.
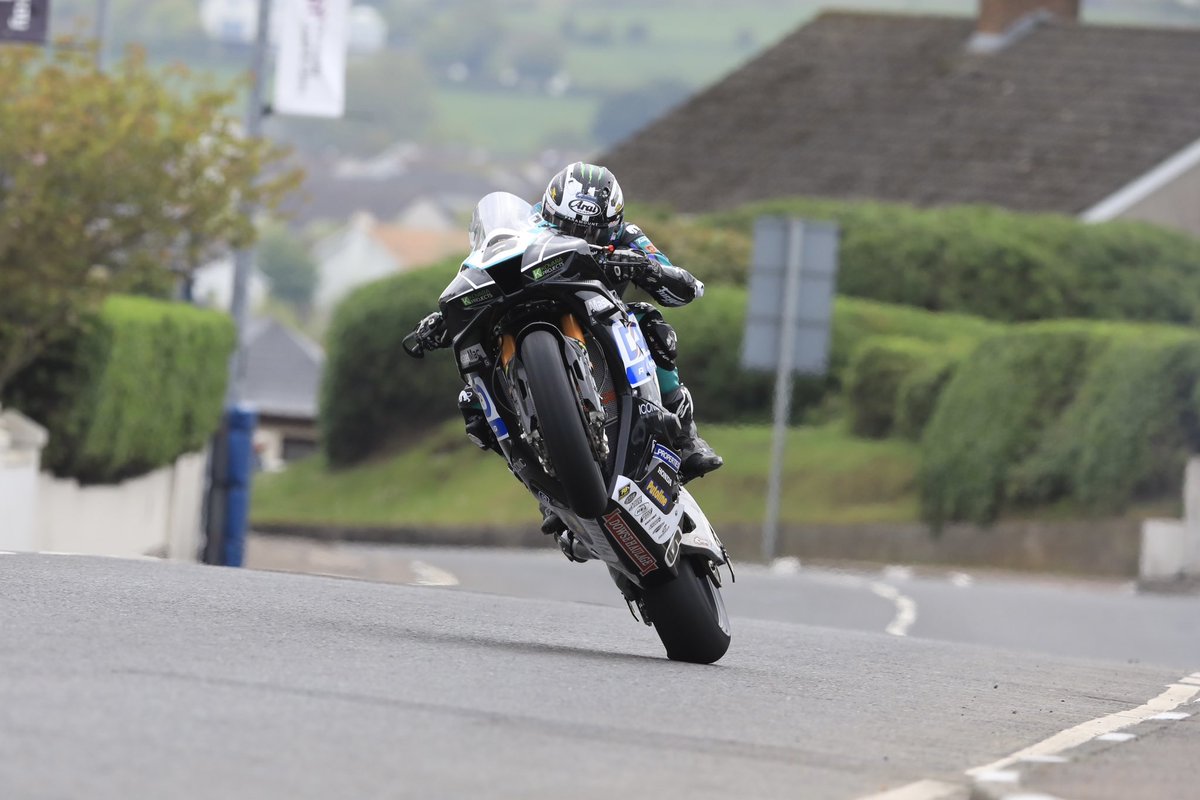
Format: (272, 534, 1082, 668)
(274, 0, 350, 116)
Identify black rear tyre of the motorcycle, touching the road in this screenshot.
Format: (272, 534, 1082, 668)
(644, 557, 730, 664)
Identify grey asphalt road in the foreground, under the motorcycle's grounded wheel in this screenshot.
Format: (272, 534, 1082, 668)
(0, 555, 1200, 800)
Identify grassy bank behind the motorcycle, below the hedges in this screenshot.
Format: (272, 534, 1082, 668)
(252, 422, 917, 528)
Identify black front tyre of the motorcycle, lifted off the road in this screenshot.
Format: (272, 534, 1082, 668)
(521, 331, 608, 517)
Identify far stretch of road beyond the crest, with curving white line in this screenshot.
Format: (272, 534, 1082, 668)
(243, 537, 1200, 670)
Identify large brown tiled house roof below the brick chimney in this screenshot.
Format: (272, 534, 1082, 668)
(601, 12, 1200, 213)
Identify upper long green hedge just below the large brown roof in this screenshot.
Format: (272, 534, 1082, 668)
(672, 199, 1200, 323)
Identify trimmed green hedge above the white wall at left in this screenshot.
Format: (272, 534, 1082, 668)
(6, 297, 235, 483)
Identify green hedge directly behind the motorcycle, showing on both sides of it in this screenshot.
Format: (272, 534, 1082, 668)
(322, 261, 998, 465)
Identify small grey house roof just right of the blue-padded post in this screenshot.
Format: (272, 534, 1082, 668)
(246, 319, 325, 420)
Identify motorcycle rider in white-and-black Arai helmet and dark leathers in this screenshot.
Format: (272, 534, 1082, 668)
(416, 162, 725, 534)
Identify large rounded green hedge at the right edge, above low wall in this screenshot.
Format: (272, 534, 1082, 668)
(919, 321, 1200, 527)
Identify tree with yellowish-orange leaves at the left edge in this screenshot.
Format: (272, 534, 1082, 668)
(0, 46, 299, 389)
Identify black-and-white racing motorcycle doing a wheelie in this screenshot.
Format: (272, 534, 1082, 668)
(404, 192, 733, 663)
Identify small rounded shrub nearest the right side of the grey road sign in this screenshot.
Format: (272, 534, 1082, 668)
(846, 336, 944, 439)
